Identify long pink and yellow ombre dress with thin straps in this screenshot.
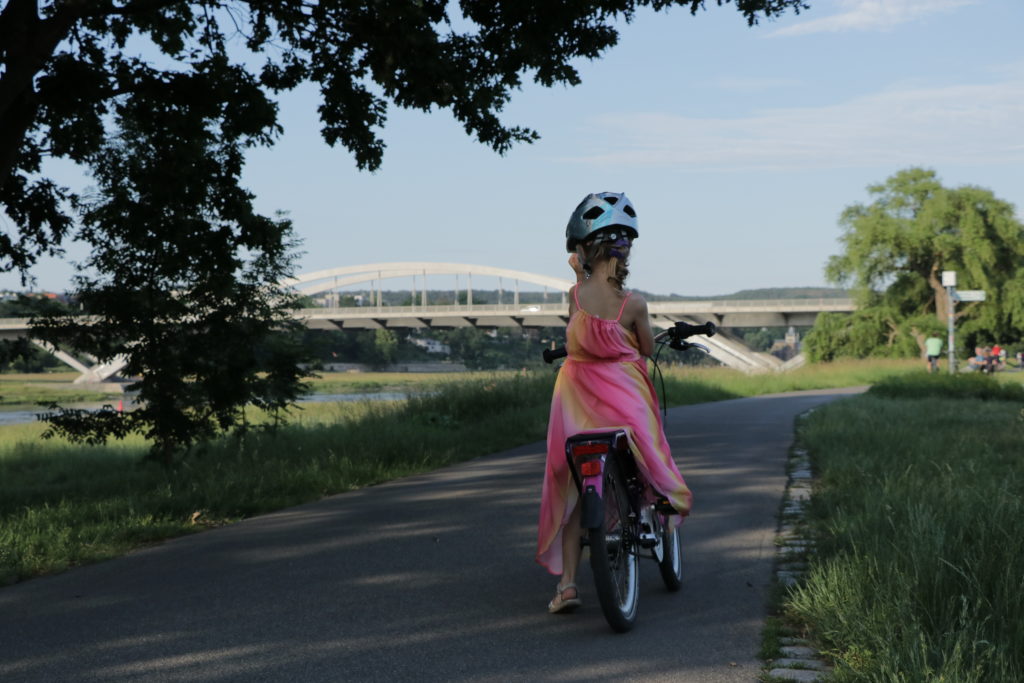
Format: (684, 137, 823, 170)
(537, 288, 692, 574)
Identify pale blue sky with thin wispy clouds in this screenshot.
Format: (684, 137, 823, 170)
(0, 0, 1024, 296)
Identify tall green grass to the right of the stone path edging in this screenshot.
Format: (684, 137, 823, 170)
(785, 374, 1024, 683)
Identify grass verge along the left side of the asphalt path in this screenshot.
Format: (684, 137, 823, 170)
(0, 361, 991, 584)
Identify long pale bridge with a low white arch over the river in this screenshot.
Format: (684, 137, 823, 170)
(0, 261, 854, 382)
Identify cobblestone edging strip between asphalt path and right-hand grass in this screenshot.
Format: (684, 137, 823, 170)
(763, 436, 831, 682)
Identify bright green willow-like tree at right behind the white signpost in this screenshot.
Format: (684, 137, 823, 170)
(805, 168, 1024, 357)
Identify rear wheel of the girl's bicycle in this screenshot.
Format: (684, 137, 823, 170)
(590, 458, 640, 633)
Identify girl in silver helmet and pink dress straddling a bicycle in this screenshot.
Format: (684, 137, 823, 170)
(537, 193, 692, 612)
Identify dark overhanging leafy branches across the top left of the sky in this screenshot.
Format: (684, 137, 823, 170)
(0, 0, 804, 275)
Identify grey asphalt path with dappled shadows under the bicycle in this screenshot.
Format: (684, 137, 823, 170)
(0, 389, 856, 683)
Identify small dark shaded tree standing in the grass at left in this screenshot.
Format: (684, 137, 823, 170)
(35, 99, 303, 463)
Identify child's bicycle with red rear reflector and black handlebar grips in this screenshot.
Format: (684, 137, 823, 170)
(544, 323, 716, 633)
